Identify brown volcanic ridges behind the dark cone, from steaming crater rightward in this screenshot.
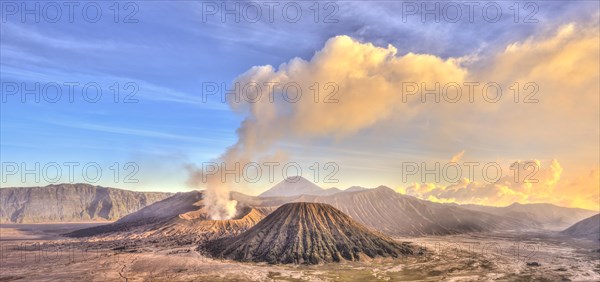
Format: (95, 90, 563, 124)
(71, 177, 591, 241)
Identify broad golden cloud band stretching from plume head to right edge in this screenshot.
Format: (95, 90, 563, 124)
(230, 19, 600, 150)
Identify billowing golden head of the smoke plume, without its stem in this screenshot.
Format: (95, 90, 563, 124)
(231, 36, 466, 138)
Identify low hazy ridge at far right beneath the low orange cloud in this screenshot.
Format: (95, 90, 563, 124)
(461, 203, 598, 230)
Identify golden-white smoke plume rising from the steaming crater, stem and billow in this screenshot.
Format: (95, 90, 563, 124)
(190, 36, 464, 219)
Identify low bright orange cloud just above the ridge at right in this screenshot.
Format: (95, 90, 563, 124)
(398, 160, 600, 210)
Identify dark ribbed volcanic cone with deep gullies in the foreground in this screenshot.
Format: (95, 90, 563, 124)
(203, 203, 412, 264)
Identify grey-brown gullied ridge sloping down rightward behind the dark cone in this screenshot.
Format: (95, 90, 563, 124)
(254, 186, 536, 236)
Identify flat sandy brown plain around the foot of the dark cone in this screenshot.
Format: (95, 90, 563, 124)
(0, 223, 600, 282)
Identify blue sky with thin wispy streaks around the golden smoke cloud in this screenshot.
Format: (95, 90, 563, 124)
(0, 1, 598, 203)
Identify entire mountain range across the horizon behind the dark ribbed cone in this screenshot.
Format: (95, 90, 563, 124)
(8, 179, 597, 240)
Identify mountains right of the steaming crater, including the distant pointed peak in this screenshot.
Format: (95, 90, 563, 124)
(259, 177, 598, 232)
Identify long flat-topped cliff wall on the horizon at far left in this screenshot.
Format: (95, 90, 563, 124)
(0, 184, 171, 223)
